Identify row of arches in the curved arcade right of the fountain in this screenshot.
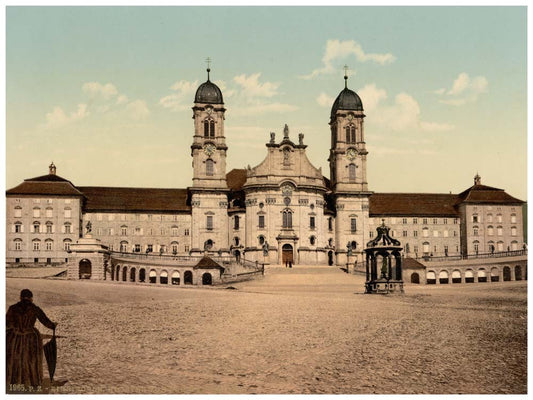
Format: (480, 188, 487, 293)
(410, 265, 527, 285)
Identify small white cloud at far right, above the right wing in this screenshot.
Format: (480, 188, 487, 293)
(434, 72, 489, 106)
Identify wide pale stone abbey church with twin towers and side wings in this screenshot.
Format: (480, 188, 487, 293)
(6, 69, 525, 266)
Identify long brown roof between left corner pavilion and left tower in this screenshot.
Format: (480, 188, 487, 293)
(79, 186, 191, 212)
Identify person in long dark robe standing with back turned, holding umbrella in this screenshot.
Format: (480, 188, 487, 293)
(6, 289, 56, 391)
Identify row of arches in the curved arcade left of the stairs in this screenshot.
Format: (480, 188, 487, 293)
(110, 265, 213, 286)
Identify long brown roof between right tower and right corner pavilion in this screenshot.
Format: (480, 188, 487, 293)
(369, 193, 459, 217)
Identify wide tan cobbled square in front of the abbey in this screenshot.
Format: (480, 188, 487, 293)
(6, 266, 527, 394)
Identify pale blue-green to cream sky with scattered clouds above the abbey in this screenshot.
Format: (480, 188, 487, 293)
(6, 7, 527, 200)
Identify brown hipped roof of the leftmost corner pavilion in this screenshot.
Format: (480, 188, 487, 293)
(6, 174, 83, 196)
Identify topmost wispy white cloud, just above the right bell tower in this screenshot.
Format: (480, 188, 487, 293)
(300, 39, 396, 79)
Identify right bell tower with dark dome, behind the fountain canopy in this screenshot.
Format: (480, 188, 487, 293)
(328, 66, 372, 268)
